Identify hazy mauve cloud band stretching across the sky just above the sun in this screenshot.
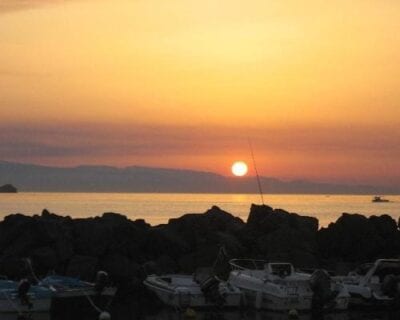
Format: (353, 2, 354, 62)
(0, 123, 400, 157)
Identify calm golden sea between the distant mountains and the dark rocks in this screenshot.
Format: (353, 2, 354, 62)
(0, 192, 400, 226)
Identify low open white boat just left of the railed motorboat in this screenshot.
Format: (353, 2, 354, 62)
(144, 274, 242, 308)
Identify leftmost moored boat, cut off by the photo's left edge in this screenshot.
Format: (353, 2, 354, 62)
(0, 280, 52, 318)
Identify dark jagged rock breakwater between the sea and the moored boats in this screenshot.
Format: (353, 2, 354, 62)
(0, 205, 400, 303)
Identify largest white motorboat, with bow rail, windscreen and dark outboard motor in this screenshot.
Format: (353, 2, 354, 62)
(228, 259, 350, 311)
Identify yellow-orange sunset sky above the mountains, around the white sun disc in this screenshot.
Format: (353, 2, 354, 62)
(0, 0, 400, 186)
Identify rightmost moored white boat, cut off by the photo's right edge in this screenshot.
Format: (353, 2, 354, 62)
(336, 259, 400, 305)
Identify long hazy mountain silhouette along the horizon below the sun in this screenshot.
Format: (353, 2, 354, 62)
(0, 161, 400, 194)
